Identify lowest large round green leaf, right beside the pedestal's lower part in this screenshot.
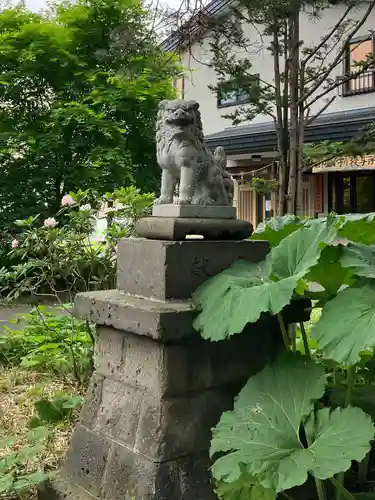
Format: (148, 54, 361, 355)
(211, 356, 325, 491)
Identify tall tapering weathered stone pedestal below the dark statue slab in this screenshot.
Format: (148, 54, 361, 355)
(40, 238, 288, 500)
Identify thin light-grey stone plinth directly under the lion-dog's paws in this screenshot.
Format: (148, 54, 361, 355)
(152, 203, 237, 219)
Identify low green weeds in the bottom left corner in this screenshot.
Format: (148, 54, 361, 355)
(0, 427, 48, 498)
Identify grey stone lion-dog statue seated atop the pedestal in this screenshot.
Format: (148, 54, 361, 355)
(155, 100, 233, 205)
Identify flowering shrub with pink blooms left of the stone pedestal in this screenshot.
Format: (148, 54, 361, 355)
(0, 187, 154, 301)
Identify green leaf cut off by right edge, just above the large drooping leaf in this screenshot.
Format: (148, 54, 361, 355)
(341, 243, 375, 278)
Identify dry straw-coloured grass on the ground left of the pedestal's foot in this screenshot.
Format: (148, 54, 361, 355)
(0, 367, 82, 500)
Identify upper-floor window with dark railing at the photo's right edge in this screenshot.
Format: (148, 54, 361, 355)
(342, 37, 375, 97)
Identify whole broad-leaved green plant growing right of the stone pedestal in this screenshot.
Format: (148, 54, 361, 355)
(193, 214, 375, 500)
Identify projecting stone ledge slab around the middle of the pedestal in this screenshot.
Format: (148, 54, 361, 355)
(74, 290, 194, 342)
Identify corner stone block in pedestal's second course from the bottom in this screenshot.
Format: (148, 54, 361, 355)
(134, 389, 233, 461)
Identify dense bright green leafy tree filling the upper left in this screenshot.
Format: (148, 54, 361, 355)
(0, 0, 179, 227)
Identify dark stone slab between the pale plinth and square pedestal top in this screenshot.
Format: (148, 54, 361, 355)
(136, 217, 253, 241)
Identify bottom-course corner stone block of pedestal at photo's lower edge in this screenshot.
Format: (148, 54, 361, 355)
(101, 443, 181, 500)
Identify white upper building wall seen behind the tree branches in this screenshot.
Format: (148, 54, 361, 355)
(181, 6, 375, 135)
